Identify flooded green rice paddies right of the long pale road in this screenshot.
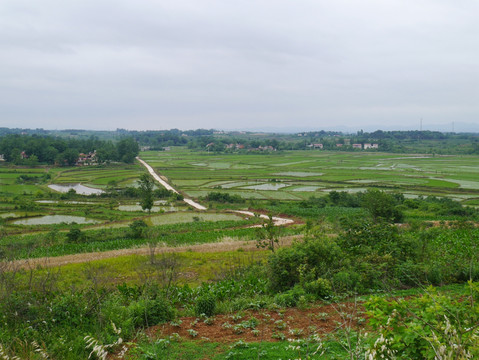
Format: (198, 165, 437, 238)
(140, 148, 479, 204)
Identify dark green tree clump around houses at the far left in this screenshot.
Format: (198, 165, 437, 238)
(0, 134, 139, 166)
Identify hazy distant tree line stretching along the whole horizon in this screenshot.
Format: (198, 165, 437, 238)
(0, 128, 479, 155)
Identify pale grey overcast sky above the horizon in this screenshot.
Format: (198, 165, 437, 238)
(0, 0, 479, 131)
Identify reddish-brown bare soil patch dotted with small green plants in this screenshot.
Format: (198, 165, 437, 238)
(147, 303, 364, 343)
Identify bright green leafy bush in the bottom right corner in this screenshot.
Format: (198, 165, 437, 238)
(365, 282, 479, 359)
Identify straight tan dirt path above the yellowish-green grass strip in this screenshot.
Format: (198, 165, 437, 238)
(11, 235, 302, 269)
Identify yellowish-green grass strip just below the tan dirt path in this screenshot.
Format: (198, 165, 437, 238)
(17, 246, 270, 290)
